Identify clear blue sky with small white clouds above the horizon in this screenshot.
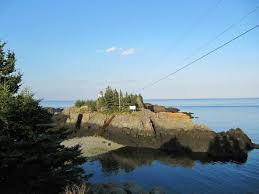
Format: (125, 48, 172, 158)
(0, 0, 259, 100)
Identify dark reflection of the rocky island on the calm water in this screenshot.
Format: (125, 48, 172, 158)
(92, 147, 246, 175)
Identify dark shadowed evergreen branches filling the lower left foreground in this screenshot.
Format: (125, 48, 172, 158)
(0, 42, 85, 193)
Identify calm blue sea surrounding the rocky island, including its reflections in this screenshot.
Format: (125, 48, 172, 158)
(42, 98, 259, 193)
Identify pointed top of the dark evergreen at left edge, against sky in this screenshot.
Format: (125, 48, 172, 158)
(0, 41, 22, 93)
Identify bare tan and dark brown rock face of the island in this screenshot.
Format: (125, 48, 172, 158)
(64, 107, 255, 159)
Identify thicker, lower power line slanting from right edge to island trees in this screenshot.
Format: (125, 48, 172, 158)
(138, 24, 259, 91)
